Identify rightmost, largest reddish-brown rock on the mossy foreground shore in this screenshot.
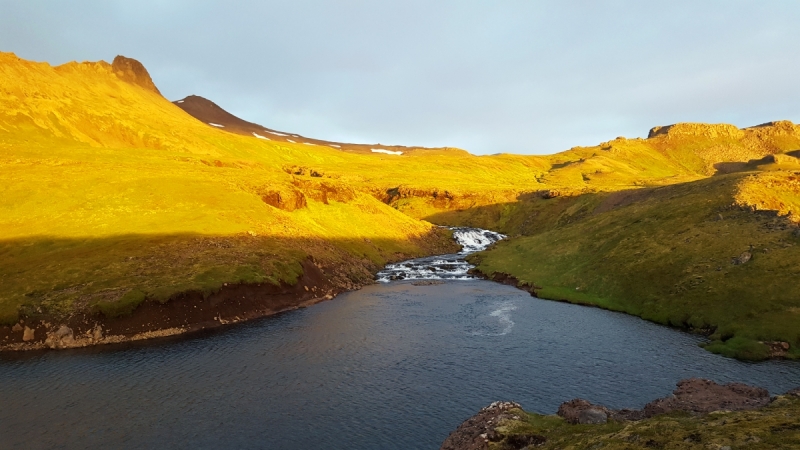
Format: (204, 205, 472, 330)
(644, 378, 770, 417)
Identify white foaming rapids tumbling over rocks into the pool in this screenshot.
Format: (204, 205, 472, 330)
(375, 227, 506, 283)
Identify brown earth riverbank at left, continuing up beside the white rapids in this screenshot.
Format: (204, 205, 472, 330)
(0, 228, 459, 352)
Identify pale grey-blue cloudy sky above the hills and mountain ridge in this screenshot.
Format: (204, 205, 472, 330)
(0, 0, 800, 154)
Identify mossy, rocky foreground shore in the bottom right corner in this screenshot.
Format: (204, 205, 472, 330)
(441, 378, 800, 450)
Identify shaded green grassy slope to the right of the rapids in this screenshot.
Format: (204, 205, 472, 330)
(466, 173, 800, 359)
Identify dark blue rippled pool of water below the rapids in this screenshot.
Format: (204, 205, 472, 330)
(0, 280, 800, 449)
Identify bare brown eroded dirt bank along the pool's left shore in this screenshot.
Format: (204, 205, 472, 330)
(0, 258, 382, 351)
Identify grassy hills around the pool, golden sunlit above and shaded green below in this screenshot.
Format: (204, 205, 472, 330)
(0, 53, 800, 354)
